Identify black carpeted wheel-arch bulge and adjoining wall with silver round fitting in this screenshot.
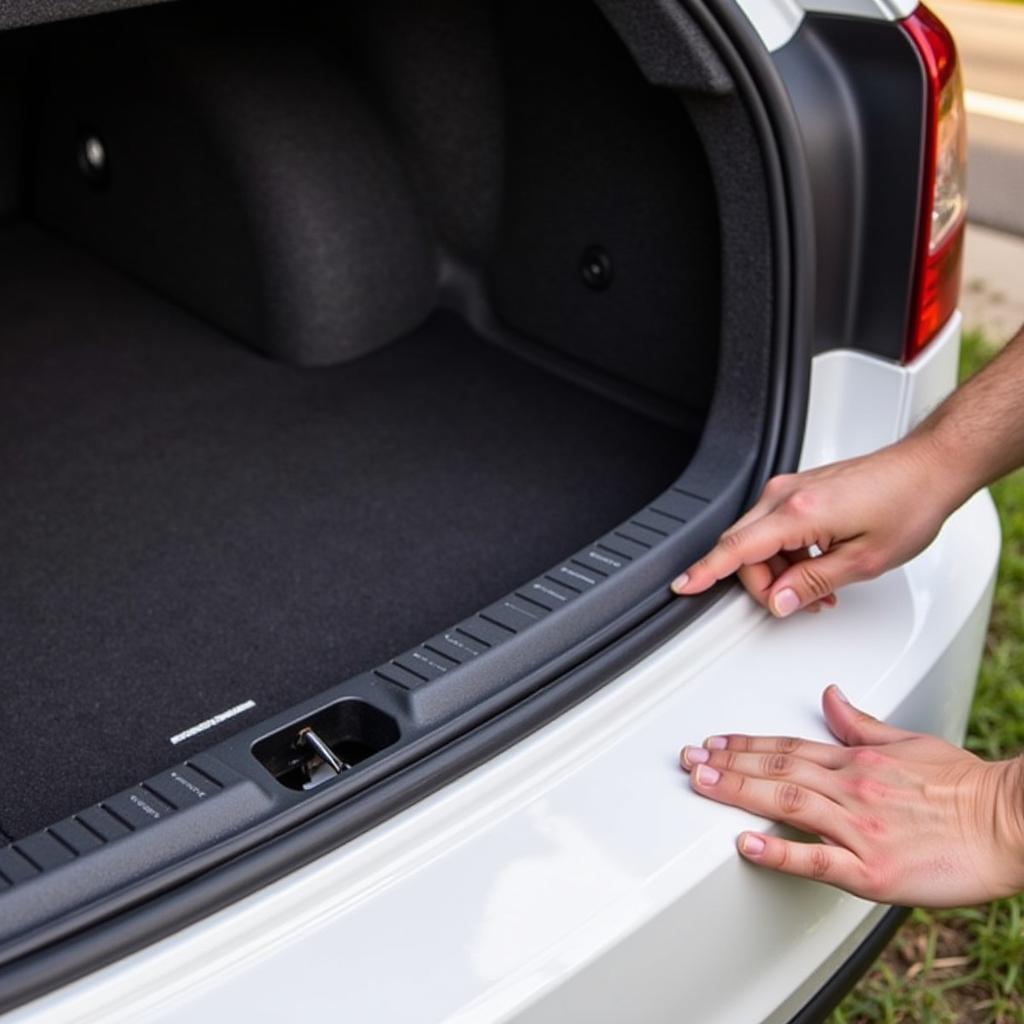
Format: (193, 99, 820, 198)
(32, 7, 436, 366)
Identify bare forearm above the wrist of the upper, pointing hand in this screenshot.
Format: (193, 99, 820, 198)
(904, 329, 1024, 512)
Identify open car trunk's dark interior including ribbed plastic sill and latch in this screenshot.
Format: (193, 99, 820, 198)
(0, 0, 782, 974)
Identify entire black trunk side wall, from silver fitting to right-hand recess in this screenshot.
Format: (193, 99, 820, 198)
(19, 0, 719, 414)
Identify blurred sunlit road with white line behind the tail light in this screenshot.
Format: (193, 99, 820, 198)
(929, 0, 1024, 235)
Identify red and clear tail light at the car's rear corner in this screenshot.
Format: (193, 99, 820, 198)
(903, 4, 967, 361)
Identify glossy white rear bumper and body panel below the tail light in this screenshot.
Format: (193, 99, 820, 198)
(5, 317, 998, 1024)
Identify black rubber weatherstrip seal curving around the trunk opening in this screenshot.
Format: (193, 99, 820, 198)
(0, 0, 814, 1012)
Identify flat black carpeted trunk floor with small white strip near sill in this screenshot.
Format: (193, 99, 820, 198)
(0, 226, 694, 839)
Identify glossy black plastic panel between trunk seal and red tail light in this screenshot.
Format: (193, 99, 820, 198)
(773, 13, 927, 359)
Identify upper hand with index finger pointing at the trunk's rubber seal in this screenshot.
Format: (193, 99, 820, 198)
(672, 435, 964, 617)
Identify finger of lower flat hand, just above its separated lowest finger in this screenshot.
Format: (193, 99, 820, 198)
(690, 765, 857, 845)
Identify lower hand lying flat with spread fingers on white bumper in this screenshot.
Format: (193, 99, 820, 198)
(680, 686, 1024, 907)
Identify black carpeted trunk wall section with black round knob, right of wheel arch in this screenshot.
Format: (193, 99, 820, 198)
(493, 0, 720, 413)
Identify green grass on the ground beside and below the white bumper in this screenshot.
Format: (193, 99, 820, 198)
(830, 335, 1024, 1024)
